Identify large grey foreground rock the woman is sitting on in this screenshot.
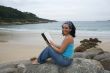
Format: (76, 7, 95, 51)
(0, 58, 104, 73)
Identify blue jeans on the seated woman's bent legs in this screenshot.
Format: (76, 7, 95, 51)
(38, 47, 72, 66)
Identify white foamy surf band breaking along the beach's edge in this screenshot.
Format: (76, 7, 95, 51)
(0, 28, 110, 36)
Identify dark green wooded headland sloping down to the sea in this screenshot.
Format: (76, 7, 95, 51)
(0, 5, 54, 24)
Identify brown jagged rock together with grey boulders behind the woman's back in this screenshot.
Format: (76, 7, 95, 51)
(74, 38, 110, 71)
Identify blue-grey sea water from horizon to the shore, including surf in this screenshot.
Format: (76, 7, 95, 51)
(0, 21, 110, 36)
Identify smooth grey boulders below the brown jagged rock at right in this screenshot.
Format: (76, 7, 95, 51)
(74, 48, 110, 71)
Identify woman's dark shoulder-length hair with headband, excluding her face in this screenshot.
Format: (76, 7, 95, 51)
(62, 21, 76, 37)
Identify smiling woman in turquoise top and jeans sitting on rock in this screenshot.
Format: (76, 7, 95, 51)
(31, 21, 76, 66)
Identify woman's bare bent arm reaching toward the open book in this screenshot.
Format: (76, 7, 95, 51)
(50, 36, 73, 53)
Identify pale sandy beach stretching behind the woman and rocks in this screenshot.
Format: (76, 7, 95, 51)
(0, 31, 110, 63)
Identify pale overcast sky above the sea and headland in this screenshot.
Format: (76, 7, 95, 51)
(0, 0, 110, 21)
